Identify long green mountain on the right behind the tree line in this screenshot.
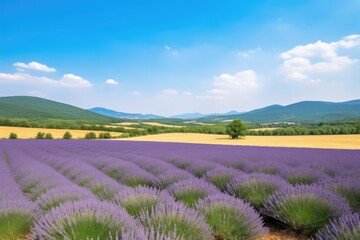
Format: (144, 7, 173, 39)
(200, 100, 360, 123)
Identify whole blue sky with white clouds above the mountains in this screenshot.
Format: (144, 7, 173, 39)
(0, 0, 360, 116)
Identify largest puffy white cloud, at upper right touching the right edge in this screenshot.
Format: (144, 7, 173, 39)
(280, 35, 360, 82)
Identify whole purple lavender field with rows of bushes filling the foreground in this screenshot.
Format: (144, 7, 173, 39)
(0, 140, 360, 240)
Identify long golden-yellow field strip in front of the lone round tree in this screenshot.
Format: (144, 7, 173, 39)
(119, 133, 360, 149)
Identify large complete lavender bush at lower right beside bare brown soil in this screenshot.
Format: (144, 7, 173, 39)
(261, 185, 351, 233)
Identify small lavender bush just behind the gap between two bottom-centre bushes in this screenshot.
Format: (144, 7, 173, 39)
(167, 179, 219, 207)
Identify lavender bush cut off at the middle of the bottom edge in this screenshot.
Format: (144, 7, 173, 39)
(140, 203, 214, 240)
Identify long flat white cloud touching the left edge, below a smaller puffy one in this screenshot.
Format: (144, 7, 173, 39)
(0, 73, 92, 88)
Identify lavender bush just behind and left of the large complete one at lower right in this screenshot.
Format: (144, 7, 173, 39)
(227, 173, 289, 209)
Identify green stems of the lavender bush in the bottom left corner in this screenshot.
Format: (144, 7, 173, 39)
(0, 212, 33, 240)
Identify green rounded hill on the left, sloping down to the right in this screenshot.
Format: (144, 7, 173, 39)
(0, 96, 114, 122)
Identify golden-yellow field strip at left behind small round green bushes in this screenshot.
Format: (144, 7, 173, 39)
(0, 127, 122, 139)
